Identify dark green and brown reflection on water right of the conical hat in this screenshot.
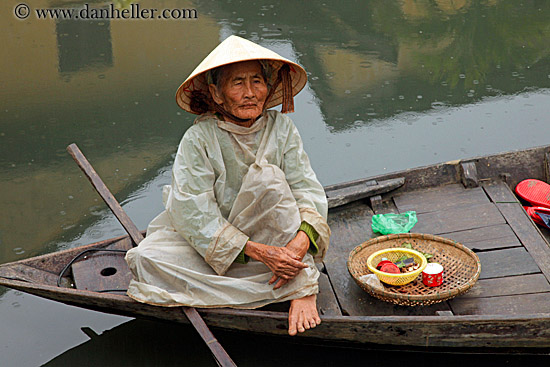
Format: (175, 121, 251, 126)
(201, 0, 550, 130)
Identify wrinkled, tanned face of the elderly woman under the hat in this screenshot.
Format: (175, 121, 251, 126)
(209, 61, 267, 120)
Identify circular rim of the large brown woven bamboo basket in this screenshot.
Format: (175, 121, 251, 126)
(346, 233, 481, 305)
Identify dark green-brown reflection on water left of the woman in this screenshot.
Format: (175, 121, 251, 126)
(0, 1, 219, 262)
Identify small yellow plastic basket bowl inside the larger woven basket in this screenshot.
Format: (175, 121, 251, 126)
(367, 247, 428, 285)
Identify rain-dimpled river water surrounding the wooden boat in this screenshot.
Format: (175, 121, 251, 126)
(0, 0, 550, 366)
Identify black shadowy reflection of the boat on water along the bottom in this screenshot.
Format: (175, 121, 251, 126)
(44, 320, 546, 367)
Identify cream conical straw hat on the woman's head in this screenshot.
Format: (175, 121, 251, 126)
(176, 36, 307, 114)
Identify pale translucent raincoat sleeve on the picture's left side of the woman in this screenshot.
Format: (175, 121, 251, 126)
(166, 128, 248, 275)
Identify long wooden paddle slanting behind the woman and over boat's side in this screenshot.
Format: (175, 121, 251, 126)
(67, 143, 237, 367)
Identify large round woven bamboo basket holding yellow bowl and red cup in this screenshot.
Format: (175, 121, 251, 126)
(347, 233, 481, 306)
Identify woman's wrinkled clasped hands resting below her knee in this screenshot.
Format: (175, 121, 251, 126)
(244, 236, 308, 289)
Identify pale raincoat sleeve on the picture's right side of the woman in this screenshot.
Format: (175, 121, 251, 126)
(281, 115, 330, 261)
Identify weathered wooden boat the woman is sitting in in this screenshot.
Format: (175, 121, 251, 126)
(0, 146, 550, 354)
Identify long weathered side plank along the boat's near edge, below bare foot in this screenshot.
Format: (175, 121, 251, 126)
(4, 268, 550, 348)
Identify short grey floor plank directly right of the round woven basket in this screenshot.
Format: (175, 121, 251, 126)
(477, 247, 540, 279)
